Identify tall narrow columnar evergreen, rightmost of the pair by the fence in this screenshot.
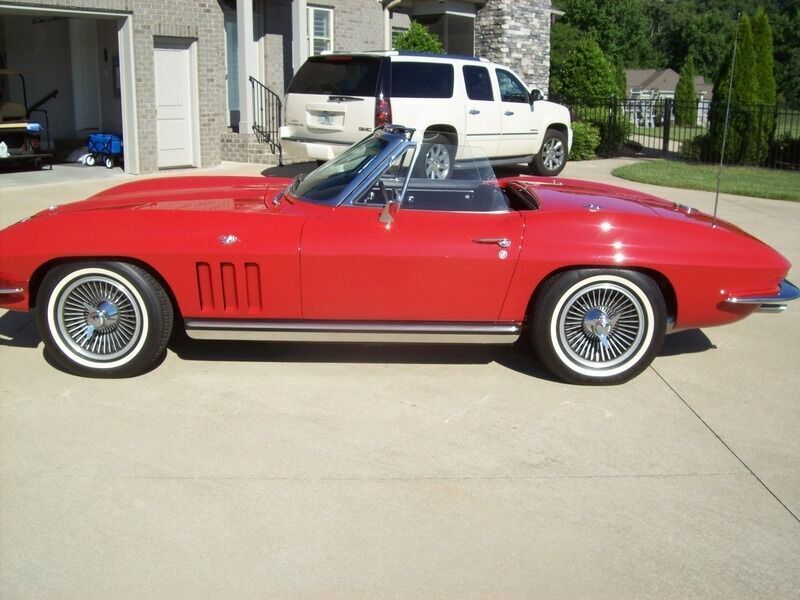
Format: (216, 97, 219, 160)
(753, 7, 777, 162)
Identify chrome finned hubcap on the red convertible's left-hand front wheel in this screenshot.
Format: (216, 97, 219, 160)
(56, 276, 142, 360)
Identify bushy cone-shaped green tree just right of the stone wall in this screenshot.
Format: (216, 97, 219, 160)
(550, 37, 618, 105)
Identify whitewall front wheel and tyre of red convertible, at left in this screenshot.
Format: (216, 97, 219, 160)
(36, 262, 173, 377)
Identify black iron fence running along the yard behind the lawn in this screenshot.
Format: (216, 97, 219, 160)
(570, 98, 800, 170)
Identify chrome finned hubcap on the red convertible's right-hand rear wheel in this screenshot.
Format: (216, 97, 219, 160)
(558, 283, 645, 369)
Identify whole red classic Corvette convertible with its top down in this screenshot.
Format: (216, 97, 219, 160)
(0, 126, 800, 383)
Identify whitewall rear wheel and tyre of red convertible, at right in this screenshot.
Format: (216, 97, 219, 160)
(532, 269, 666, 384)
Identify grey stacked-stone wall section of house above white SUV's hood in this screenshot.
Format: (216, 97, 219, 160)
(475, 0, 551, 94)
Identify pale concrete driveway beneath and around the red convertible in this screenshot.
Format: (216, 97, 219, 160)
(0, 160, 800, 600)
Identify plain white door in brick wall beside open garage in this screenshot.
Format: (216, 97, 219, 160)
(155, 40, 197, 169)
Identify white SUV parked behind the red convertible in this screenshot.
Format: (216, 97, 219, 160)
(280, 51, 572, 179)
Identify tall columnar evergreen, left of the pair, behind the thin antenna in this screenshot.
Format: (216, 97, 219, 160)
(709, 15, 758, 163)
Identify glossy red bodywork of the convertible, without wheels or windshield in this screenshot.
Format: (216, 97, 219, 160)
(0, 127, 791, 384)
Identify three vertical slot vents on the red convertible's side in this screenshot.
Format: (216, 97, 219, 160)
(196, 262, 263, 314)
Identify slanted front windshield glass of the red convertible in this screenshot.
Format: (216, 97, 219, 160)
(290, 136, 391, 204)
